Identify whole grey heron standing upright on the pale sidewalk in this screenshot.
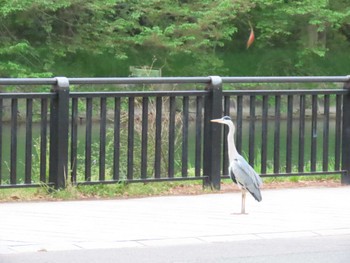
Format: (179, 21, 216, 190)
(211, 116, 262, 214)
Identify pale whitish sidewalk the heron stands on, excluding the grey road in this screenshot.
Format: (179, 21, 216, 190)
(0, 187, 350, 254)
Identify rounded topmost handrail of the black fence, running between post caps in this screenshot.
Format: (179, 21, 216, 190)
(0, 75, 350, 85)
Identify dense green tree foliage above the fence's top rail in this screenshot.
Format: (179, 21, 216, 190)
(0, 0, 350, 77)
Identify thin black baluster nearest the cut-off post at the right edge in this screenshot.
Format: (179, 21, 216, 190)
(334, 95, 342, 171)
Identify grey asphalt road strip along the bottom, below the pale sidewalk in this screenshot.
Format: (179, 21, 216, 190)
(0, 235, 350, 263)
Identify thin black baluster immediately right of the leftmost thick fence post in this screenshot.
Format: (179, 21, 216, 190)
(70, 98, 78, 184)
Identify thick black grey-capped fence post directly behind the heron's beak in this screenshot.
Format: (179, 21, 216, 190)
(203, 76, 222, 190)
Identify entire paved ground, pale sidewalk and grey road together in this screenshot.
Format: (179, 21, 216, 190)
(0, 187, 350, 262)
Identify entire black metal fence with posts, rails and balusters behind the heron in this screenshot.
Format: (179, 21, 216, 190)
(0, 76, 350, 188)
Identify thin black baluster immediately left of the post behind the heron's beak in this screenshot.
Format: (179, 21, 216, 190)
(195, 96, 203, 177)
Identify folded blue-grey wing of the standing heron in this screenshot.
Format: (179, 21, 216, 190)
(231, 156, 262, 201)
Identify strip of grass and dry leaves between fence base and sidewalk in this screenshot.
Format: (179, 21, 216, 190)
(0, 175, 340, 202)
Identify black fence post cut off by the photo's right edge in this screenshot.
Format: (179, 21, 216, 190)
(341, 76, 350, 184)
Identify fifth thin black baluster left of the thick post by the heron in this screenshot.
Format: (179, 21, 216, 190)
(141, 97, 148, 179)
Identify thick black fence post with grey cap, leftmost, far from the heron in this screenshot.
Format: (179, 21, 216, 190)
(49, 77, 69, 189)
